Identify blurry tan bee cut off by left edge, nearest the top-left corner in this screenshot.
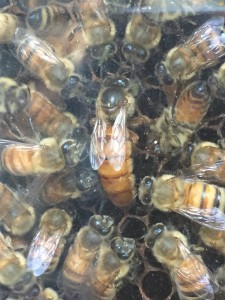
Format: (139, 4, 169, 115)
(0, 13, 22, 43)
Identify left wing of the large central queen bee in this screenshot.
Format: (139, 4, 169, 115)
(89, 118, 106, 170)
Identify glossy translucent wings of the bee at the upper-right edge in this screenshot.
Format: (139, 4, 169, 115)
(182, 16, 225, 71)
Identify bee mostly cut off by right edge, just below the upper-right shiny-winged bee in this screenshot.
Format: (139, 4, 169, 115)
(208, 63, 225, 99)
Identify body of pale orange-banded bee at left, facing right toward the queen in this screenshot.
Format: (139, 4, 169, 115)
(1, 138, 65, 176)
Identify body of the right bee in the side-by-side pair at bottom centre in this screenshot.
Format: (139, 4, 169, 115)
(89, 244, 121, 300)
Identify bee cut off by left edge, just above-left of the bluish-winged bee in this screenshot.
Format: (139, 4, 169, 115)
(0, 182, 35, 236)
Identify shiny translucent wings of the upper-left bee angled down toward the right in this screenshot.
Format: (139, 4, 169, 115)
(9, 27, 63, 68)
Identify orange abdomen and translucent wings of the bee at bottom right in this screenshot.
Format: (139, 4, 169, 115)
(171, 242, 218, 300)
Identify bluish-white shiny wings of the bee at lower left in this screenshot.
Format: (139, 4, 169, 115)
(27, 229, 63, 276)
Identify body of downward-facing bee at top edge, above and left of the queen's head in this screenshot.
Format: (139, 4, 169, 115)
(74, 0, 115, 46)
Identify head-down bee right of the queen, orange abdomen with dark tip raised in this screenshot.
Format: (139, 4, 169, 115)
(150, 81, 211, 154)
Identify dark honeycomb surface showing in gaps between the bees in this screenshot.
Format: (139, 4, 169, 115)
(0, 0, 225, 300)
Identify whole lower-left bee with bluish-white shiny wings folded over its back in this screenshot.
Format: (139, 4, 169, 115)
(27, 208, 72, 276)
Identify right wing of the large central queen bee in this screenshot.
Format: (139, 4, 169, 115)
(108, 106, 126, 171)
